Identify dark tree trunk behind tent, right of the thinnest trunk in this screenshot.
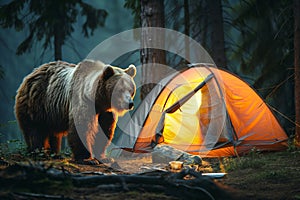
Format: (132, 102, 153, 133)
(206, 0, 226, 68)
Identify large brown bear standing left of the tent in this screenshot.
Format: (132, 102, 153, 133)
(15, 60, 136, 164)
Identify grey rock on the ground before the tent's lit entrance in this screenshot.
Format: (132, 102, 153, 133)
(152, 145, 202, 165)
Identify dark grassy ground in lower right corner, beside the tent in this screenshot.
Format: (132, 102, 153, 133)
(222, 148, 300, 200)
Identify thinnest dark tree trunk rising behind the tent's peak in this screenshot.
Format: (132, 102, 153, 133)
(183, 0, 190, 60)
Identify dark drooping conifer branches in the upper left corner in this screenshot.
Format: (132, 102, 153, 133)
(0, 0, 107, 54)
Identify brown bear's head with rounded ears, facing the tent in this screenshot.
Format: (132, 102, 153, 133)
(101, 65, 136, 116)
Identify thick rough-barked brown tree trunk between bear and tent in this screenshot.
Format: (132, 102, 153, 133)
(140, 0, 166, 99)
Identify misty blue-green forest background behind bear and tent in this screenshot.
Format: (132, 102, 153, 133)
(0, 0, 299, 150)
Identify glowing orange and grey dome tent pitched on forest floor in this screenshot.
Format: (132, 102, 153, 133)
(116, 64, 287, 157)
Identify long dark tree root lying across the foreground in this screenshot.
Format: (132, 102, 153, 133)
(0, 164, 232, 200)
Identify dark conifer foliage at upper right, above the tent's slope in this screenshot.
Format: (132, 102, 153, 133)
(228, 0, 293, 90)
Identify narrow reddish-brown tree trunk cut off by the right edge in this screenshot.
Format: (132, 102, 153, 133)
(294, 0, 300, 145)
